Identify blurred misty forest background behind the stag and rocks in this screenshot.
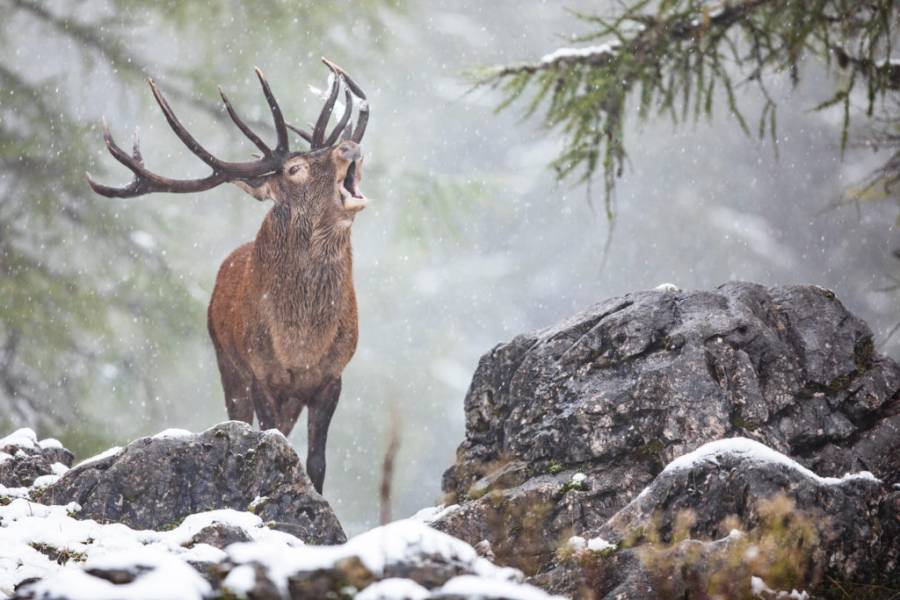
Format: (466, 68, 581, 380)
(0, 0, 900, 534)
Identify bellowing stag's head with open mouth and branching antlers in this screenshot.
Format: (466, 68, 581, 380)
(88, 59, 369, 224)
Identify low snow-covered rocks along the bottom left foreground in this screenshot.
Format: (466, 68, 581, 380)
(7, 499, 568, 600)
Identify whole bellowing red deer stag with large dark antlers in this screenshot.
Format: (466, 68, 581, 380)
(88, 59, 369, 493)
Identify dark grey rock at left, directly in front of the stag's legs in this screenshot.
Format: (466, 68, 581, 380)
(40, 421, 346, 544)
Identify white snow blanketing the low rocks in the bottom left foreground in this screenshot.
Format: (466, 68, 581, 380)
(0, 490, 551, 600)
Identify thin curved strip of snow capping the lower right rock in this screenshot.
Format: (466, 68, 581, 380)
(663, 437, 881, 485)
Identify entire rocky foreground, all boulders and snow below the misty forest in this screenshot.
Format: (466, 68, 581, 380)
(0, 284, 900, 600)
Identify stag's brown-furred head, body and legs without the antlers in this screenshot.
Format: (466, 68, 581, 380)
(208, 141, 361, 491)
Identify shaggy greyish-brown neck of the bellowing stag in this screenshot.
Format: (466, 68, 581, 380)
(254, 206, 353, 330)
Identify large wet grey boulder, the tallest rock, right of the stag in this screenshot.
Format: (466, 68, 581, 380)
(434, 283, 900, 574)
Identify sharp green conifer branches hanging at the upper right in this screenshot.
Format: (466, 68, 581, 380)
(486, 0, 900, 218)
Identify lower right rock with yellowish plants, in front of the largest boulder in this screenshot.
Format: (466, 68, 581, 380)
(564, 440, 900, 600)
